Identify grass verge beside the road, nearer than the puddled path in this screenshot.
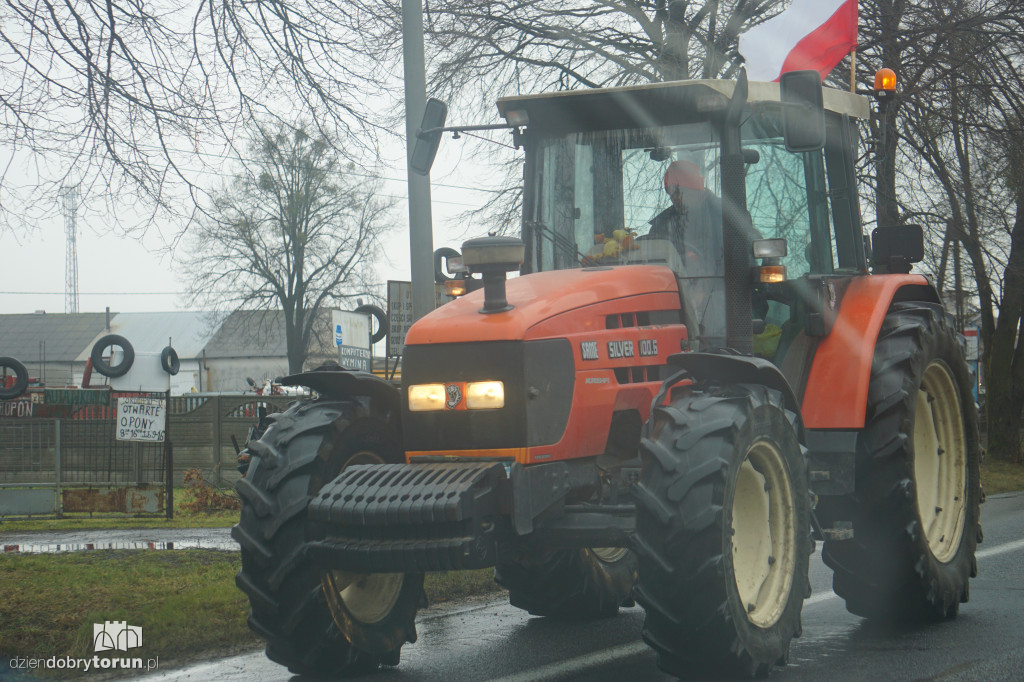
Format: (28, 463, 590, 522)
(0, 550, 501, 677)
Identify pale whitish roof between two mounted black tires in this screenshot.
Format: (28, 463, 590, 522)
(78, 311, 219, 363)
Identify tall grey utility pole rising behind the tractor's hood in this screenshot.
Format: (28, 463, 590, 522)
(401, 0, 434, 321)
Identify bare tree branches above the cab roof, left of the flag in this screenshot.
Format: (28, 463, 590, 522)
(344, 0, 783, 112)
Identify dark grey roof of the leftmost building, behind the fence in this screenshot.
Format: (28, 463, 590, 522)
(0, 312, 106, 363)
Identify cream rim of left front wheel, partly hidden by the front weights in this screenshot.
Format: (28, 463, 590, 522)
(322, 451, 406, 625)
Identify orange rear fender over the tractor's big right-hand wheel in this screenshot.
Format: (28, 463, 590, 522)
(803, 274, 940, 429)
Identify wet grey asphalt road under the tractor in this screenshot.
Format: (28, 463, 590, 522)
(138, 494, 1024, 682)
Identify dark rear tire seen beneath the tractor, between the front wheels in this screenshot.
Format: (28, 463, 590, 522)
(495, 547, 637, 619)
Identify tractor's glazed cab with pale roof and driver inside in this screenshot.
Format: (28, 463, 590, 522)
(498, 76, 868, 384)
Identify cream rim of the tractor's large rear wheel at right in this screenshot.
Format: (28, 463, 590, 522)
(913, 360, 967, 563)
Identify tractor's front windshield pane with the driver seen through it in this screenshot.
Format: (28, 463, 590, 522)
(532, 123, 722, 276)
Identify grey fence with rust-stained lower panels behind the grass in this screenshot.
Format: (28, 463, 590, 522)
(0, 394, 296, 517)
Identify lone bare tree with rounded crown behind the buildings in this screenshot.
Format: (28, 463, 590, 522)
(186, 124, 390, 373)
